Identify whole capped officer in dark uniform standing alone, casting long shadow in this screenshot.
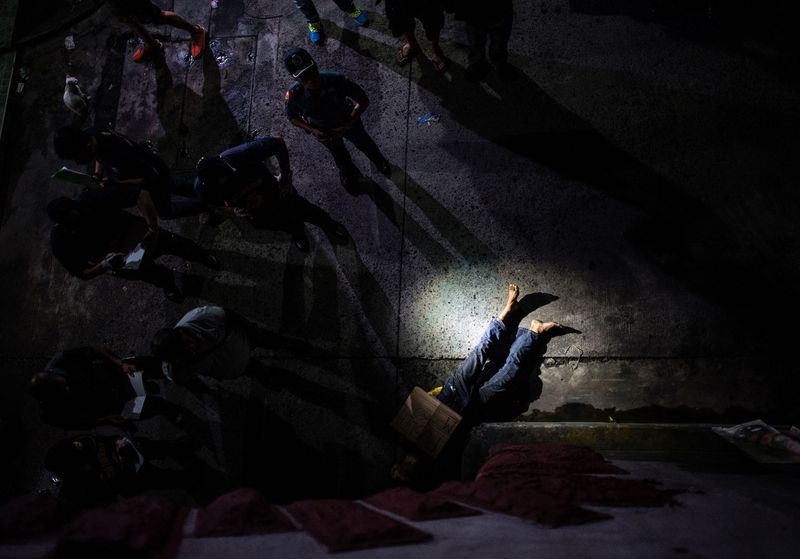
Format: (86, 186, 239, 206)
(284, 48, 392, 189)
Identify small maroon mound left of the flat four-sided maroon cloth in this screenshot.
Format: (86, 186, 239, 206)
(194, 488, 296, 537)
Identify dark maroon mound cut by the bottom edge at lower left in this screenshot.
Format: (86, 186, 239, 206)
(54, 496, 186, 559)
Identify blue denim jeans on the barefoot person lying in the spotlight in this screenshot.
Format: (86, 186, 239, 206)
(438, 318, 539, 415)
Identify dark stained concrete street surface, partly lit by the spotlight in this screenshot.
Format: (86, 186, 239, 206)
(0, 0, 800, 528)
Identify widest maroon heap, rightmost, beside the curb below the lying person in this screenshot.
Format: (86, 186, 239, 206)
(436, 444, 675, 526)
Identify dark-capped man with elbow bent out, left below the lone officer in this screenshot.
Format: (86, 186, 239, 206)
(195, 136, 348, 252)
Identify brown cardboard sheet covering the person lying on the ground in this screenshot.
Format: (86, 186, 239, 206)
(392, 386, 461, 458)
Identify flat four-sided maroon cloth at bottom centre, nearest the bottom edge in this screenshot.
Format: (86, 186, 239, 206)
(287, 499, 432, 551)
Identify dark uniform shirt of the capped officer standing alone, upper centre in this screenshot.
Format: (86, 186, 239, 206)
(284, 72, 368, 130)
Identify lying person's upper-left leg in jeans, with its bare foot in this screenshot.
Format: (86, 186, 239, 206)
(438, 284, 519, 413)
